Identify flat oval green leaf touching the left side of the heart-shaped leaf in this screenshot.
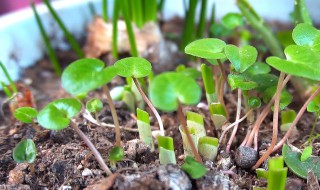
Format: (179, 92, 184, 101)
(184, 38, 226, 59)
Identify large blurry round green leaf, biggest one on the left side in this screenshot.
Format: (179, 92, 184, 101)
(61, 58, 117, 95)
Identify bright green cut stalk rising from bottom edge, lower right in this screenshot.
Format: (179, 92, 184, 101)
(256, 156, 288, 190)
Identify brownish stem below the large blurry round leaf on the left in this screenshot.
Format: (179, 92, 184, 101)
(102, 85, 121, 147)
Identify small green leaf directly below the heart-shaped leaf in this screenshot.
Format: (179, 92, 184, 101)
(228, 74, 258, 90)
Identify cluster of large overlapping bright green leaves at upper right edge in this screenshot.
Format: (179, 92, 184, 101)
(267, 24, 320, 81)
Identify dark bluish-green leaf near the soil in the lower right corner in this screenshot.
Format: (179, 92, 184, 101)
(282, 145, 320, 180)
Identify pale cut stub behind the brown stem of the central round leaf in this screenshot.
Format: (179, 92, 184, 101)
(179, 111, 206, 157)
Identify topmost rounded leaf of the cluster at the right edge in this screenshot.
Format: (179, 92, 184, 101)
(292, 23, 320, 46)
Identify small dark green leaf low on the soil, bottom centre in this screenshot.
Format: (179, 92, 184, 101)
(181, 156, 207, 179)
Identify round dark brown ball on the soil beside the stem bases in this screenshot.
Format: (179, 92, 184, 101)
(235, 146, 258, 169)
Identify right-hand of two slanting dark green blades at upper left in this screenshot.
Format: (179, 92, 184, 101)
(43, 0, 84, 58)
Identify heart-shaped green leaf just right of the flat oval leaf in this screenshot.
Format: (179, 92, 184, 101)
(224, 45, 258, 73)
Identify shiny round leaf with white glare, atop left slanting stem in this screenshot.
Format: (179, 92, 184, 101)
(37, 98, 82, 130)
